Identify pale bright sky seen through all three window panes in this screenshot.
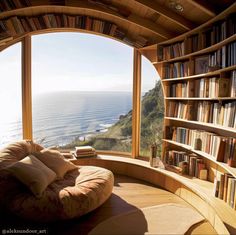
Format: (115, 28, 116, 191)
(0, 33, 159, 106)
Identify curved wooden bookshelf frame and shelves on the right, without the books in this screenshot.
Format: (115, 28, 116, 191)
(139, 3, 236, 234)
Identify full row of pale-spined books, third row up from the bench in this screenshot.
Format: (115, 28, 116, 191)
(167, 101, 236, 128)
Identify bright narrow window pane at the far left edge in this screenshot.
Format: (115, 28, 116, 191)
(0, 43, 22, 146)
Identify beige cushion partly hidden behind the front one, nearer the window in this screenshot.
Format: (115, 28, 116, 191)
(34, 149, 77, 179)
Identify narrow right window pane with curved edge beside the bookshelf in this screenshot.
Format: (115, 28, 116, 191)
(140, 57, 164, 157)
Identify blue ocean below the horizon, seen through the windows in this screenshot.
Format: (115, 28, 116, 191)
(0, 91, 132, 147)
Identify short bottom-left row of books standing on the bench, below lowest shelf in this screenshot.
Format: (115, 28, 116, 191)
(164, 150, 208, 180)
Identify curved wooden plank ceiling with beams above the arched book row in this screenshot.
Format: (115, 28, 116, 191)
(0, 0, 234, 47)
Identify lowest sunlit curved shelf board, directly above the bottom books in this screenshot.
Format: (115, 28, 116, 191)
(163, 139, 236, 177)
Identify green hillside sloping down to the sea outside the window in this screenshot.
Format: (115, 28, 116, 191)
(65, 81, 164, 156)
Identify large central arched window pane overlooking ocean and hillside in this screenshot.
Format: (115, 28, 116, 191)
(32, 33, 133, 152)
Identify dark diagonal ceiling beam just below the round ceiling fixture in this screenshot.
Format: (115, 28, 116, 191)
(135, 0, 196, 30)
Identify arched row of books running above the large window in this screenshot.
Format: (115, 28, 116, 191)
(0, 14, 148, 48)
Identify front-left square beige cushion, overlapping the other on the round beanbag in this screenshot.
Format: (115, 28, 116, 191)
(7, 155, 56, 197)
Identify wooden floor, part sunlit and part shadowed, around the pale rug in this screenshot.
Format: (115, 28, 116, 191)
(0, 175, 217, 235)
